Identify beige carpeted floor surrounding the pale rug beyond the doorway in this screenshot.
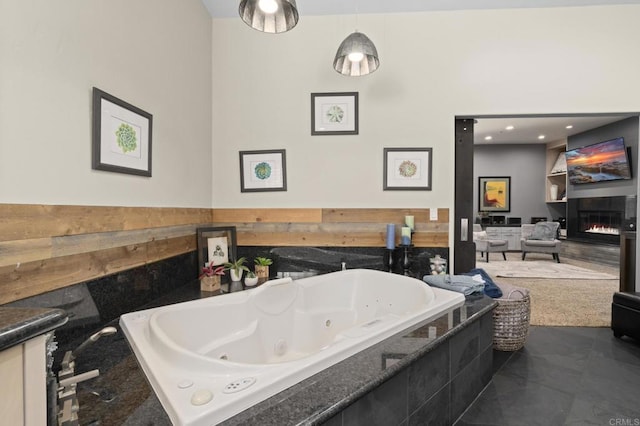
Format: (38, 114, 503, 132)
(476, 253, 620, 327)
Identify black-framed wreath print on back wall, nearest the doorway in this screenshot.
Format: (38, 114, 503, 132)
(382, 148, 432, 191)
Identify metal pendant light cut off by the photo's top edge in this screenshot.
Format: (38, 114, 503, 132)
(238, 0, 298, 33)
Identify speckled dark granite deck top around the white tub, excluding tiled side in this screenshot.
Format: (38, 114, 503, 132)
(65, 281, 496, 426)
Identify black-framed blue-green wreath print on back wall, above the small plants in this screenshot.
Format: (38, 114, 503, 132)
(240, 149, 287, 192)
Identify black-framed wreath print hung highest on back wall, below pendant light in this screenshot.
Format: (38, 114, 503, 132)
(311, 92, 358, 136)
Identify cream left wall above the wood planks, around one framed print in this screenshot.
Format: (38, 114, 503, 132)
(0, 0, 212, 207)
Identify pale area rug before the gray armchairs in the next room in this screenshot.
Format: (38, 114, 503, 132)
(477, 260, 618, 280)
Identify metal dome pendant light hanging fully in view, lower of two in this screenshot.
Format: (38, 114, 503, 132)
(333, 30, 380, 77)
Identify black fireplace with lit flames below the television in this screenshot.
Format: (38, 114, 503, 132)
(567, 196, 636, 244)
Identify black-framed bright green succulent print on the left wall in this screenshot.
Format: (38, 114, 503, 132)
(91, 87, 153, 177)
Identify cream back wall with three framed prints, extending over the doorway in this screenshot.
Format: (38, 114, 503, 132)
(213, 5, 640, 208)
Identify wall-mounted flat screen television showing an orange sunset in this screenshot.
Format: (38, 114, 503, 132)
(565, 138, 631, 185)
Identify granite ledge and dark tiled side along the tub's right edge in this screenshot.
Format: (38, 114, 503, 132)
(221, 297, 495, 426)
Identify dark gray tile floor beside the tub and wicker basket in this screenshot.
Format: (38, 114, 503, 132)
(455, 327, 640, 426)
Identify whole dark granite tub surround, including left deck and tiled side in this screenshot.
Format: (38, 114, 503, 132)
(74, 281, 495, 426)
